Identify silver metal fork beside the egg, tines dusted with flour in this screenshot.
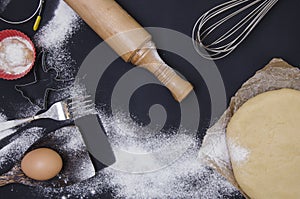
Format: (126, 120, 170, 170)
(0, 96, 96, 131)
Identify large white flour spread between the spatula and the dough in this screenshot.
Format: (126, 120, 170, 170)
(38, 111, 238, 199)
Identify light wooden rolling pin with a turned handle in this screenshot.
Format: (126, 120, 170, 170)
(65, 0, 193, 102)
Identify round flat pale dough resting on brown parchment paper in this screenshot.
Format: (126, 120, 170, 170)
(227, 89, 300, 199)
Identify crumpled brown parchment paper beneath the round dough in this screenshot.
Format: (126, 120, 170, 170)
(199, 58, 300, 197)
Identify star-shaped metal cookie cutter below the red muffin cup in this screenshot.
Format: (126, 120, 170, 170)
(15, 50, 74, 109)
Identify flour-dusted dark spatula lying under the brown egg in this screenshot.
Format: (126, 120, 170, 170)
(0, 126, 95, 187)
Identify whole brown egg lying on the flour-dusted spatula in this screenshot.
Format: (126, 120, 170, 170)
(21, 148, 63, 180)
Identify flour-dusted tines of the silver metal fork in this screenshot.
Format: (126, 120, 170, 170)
(67, 95, 97, 119)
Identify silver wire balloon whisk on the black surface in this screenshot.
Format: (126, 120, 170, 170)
(192, 0, 278, 60)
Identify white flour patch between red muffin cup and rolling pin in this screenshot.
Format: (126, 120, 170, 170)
(35, 0, 80, 78)
